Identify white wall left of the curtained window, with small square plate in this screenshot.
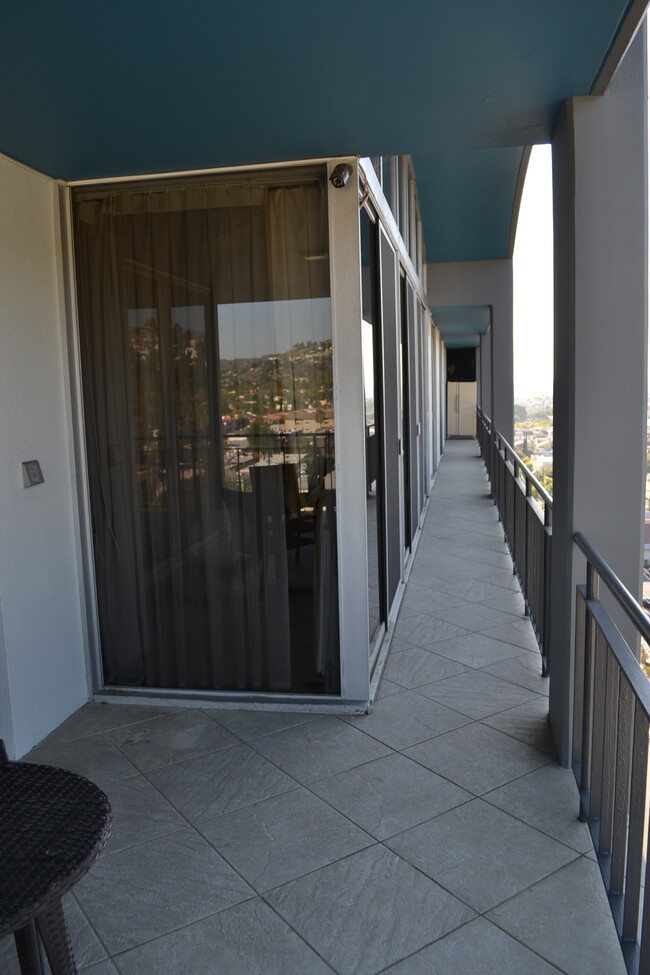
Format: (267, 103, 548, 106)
(0, 156, 88, 757)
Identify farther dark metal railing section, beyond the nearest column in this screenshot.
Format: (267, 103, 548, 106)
(477, 408, 553, 673)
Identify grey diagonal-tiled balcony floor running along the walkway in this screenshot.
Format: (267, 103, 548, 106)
(0, 441, 625, 975)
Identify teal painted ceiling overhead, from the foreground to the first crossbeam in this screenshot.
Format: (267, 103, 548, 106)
(0, 0, 629, 261)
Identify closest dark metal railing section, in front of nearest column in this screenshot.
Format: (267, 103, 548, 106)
(573, 534, 650, 975)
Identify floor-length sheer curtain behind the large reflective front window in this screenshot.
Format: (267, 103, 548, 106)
(74, 170, 339, 693)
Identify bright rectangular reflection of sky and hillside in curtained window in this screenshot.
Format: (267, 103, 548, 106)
(218, 298, 334, 496)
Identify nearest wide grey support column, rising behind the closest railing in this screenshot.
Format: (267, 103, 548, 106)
(549, 24, 647, 765)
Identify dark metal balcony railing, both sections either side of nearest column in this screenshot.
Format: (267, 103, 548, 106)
(477, 409, 650, 975)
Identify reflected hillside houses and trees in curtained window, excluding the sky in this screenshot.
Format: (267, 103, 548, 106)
(128, 316, 334, 509)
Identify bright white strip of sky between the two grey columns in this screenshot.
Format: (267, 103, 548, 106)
(513, 145, 553, 400)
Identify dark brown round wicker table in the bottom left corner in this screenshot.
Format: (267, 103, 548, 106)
(0, 761, 111, 975)
